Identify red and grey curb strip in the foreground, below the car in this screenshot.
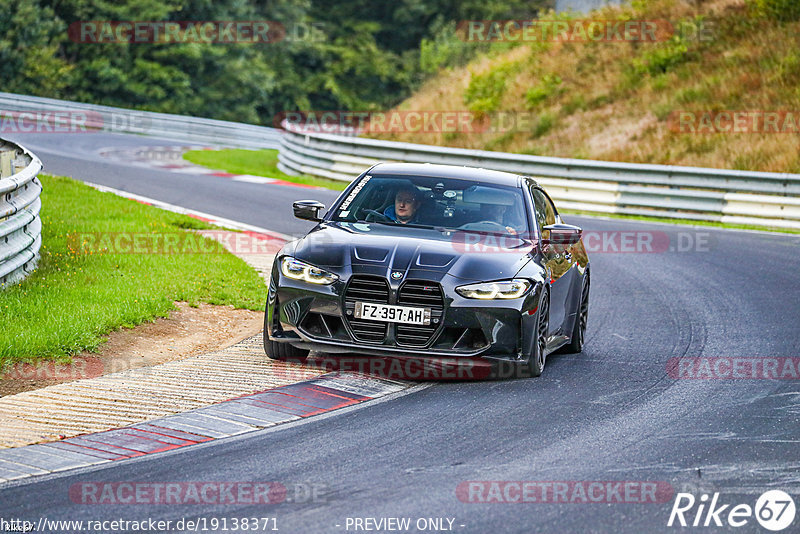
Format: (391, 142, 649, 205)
(0, 373, 410, 483)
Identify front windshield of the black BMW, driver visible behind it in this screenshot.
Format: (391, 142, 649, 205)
(332, 175, 529, 236)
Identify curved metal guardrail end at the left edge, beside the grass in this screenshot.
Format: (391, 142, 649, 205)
(0, 140, 42, 289)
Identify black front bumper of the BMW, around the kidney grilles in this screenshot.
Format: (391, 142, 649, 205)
(265, 269, 541, 361)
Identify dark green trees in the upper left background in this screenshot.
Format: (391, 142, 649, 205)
(0, 0, 549, 125)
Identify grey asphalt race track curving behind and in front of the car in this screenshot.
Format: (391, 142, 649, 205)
(0, 134, 800, 533)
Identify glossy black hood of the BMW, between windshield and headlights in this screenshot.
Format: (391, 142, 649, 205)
(283, 223, 532, 281)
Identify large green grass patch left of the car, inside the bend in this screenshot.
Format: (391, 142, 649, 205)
(0, 175, 267, 367)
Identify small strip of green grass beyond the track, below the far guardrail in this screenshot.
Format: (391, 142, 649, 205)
(183, 148, 350, 191)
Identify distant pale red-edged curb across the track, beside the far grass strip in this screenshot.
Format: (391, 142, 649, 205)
(100, 146, 322, 189)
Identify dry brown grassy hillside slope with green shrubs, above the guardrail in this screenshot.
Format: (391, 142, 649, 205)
(374, 0, 800, 173)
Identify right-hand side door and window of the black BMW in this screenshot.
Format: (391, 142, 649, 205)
(531, 186, 574, 334)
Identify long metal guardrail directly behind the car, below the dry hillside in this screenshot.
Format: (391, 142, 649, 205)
(278, 121, 800, 229)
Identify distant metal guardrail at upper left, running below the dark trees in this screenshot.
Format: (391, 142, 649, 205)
(0, 92, 281, 149)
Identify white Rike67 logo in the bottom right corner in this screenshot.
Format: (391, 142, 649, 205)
(667, 490, 796, 532)
